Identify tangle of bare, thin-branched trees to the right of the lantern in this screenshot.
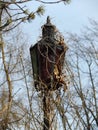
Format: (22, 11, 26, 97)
(64, 20, 98, 130)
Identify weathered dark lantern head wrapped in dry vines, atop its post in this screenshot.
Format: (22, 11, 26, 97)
(30, 16, 68, 91)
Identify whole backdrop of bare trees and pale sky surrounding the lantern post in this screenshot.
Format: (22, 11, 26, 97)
(0, 0, 98, 130)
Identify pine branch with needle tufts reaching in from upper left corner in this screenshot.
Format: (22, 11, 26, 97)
(0, 0, 44, 33)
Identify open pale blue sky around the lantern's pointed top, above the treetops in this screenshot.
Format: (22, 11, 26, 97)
(22, 0, 98, 45)
